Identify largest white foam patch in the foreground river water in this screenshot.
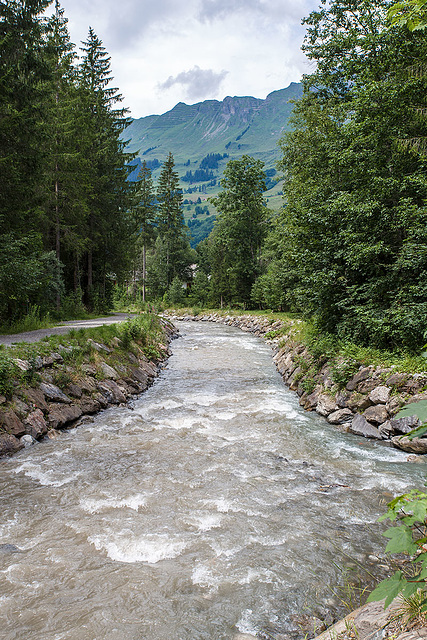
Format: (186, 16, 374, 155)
(88, 530, 187, 564)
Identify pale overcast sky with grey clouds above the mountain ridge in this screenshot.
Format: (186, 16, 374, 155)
(51, 0, 320, 118)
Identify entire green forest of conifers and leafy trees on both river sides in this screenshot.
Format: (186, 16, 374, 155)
(0, 0, 427, 351)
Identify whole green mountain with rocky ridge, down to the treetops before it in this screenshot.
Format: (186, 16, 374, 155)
(123, 82, 302, 246)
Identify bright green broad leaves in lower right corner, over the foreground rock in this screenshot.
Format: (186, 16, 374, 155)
(368, 489, 427, 612)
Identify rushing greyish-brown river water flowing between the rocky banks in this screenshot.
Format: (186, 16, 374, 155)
(0, 323, 425, 640)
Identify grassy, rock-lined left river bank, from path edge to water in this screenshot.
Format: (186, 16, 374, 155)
(0, 319, 177, 456)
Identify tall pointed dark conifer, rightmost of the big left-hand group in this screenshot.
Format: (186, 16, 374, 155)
(79, 28, 134, 305)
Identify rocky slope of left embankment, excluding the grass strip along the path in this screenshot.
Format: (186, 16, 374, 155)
(0, 320, 177, 456)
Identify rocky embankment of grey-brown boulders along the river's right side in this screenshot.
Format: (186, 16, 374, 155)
(168, 313, 427, 462)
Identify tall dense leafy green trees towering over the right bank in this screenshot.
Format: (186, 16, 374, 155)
(274, 0, 427, 353)
